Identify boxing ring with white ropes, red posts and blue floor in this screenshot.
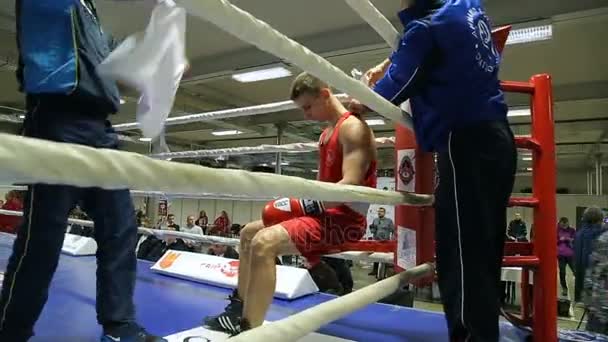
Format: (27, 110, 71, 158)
(0, 0, 576, 342)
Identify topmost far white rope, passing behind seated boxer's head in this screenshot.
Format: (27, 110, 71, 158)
(112, 94, 348, 132)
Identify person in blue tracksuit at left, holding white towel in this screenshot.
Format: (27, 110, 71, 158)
(0, 0, 165, 342)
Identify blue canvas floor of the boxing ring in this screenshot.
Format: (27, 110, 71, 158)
(0, 234, 523, 342)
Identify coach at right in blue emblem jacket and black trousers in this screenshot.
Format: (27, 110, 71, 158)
(351, 0, 517, 342)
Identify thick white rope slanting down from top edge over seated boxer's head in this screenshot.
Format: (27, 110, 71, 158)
(179, 0, 413, 130)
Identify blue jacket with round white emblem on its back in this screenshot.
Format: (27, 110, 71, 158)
(374, 0, 507, 151)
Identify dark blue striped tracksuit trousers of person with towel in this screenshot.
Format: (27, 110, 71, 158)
(0, 106, 137, 342)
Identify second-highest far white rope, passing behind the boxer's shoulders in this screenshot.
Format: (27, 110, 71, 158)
(150, 137, 395, 159)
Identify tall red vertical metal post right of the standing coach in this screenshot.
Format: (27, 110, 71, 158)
(530, 74, 557, 341)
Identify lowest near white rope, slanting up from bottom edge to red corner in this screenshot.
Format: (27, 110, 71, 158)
(229, 263, 435, 342)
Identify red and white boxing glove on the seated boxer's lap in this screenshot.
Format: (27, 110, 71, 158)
(262, 198, 325, 227)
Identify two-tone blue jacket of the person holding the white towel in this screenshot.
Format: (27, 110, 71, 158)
(15, 0, 120, 115)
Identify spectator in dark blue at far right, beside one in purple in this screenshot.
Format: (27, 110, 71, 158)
(574, 207, 604, 302)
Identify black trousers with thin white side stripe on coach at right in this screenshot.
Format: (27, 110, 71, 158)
(435, 122, 517, 342)
